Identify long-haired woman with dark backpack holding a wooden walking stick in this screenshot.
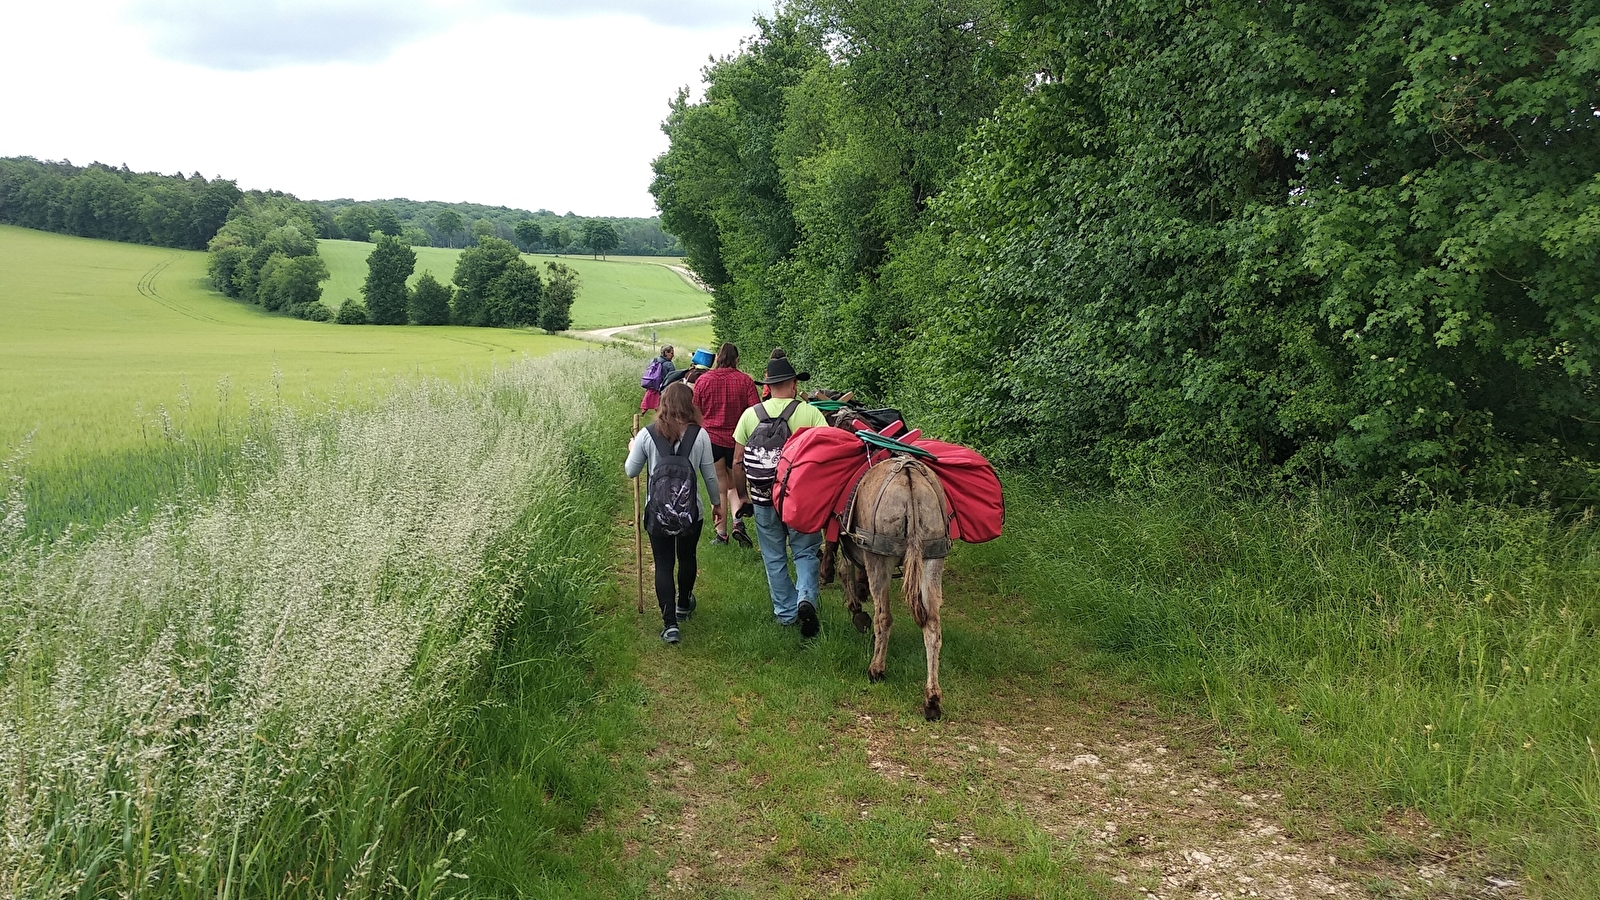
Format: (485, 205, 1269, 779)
(622, 384, 722, 644)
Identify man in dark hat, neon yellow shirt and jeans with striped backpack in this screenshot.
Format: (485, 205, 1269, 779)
(733, 357, 827, 637)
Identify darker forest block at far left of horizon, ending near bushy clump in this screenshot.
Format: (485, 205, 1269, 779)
(0, 157, 243, 250)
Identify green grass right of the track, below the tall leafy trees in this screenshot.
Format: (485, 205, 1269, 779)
(974, 482, 1600, 898)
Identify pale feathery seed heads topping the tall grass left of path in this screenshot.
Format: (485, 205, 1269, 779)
(0, 352, 632, 871)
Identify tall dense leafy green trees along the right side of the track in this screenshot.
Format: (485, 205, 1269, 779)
(651, 0, 1600, 504)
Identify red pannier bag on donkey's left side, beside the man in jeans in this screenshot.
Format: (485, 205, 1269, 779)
(773, 428, 867, 535)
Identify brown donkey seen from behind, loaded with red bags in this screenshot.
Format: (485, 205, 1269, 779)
(838, 456, 950, 722)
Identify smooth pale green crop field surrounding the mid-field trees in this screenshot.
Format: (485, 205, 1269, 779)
(0, 226, 706, 466)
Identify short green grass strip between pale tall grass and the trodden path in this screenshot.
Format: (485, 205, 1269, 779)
(434, 389, 637, 898)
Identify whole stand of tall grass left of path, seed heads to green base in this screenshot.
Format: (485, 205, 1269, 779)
(0, 352, 635, 900)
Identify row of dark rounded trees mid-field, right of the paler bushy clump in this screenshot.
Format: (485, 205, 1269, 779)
(334, 234, 579, 333)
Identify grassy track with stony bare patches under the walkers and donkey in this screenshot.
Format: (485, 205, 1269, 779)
(592, 522, 1522, 900)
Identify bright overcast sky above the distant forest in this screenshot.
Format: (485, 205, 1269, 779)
(0, 0, 771, 216)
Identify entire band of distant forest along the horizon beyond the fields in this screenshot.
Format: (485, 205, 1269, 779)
(0, 157, 683, 256)
